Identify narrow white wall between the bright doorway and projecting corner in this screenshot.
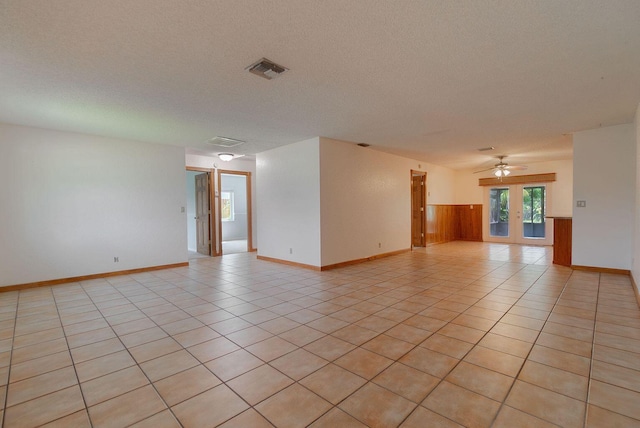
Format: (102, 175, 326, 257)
(256, 137, 321, 266)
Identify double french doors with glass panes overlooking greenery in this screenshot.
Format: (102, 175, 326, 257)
(482, 183, 553, 245)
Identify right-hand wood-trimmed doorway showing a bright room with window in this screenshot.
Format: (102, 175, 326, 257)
(216, 170, 253, 254)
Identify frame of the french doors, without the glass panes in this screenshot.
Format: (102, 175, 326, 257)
(482, 182, 553, 245)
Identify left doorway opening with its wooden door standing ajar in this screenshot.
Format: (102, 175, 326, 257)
(186, 167, 215, 259)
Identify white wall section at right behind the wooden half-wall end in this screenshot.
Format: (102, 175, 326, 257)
(572, 124, 637, 269)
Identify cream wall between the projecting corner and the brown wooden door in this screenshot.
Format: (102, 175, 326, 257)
(320, 138, 436, 266)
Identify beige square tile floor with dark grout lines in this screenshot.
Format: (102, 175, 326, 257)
(0, 242, 640, 427)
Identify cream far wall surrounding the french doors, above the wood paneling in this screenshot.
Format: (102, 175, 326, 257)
(456, 159, 573, 217)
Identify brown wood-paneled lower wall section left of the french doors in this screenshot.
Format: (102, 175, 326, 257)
(427, 204, 482, 244)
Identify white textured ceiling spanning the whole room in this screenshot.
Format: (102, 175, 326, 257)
(0, 0, 640, 169)
